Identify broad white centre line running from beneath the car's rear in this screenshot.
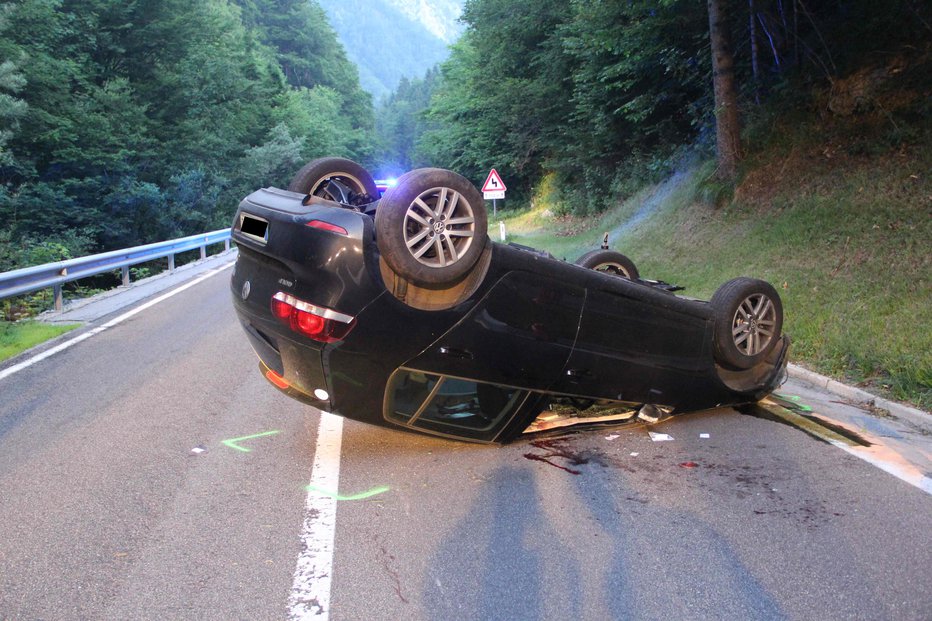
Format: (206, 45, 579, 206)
(288, 412, 343, 621)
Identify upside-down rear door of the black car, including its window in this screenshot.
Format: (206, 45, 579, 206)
(392, 271, 585, 442)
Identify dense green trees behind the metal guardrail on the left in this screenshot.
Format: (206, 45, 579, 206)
(0, 0, 374, 270)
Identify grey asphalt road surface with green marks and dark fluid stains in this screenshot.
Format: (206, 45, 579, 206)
(0, 271, 932, 621)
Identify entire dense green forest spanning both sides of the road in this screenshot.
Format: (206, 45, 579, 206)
(0, 0, 932, 271)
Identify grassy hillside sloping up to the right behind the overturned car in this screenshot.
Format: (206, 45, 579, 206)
(506, 116, 932, 410)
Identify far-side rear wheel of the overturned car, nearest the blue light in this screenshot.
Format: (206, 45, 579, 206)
(288, 157, 379, 206)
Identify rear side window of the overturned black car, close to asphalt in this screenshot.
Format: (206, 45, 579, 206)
(385, 369, 528, 441)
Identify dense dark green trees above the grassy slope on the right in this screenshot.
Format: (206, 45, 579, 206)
(383, 0, 932, 211)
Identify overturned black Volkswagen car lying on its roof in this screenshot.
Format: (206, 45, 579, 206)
(231, 158, 789, 443)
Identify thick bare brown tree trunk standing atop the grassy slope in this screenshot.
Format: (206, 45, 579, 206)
(708, 0, 741, 181)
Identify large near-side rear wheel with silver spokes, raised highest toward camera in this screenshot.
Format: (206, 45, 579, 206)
(375, 168, 488, 287)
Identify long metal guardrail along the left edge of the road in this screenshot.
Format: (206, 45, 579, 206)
(0, 229, 230, 311)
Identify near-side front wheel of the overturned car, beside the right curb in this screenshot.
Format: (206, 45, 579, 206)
(709, 278, 783, 371)
